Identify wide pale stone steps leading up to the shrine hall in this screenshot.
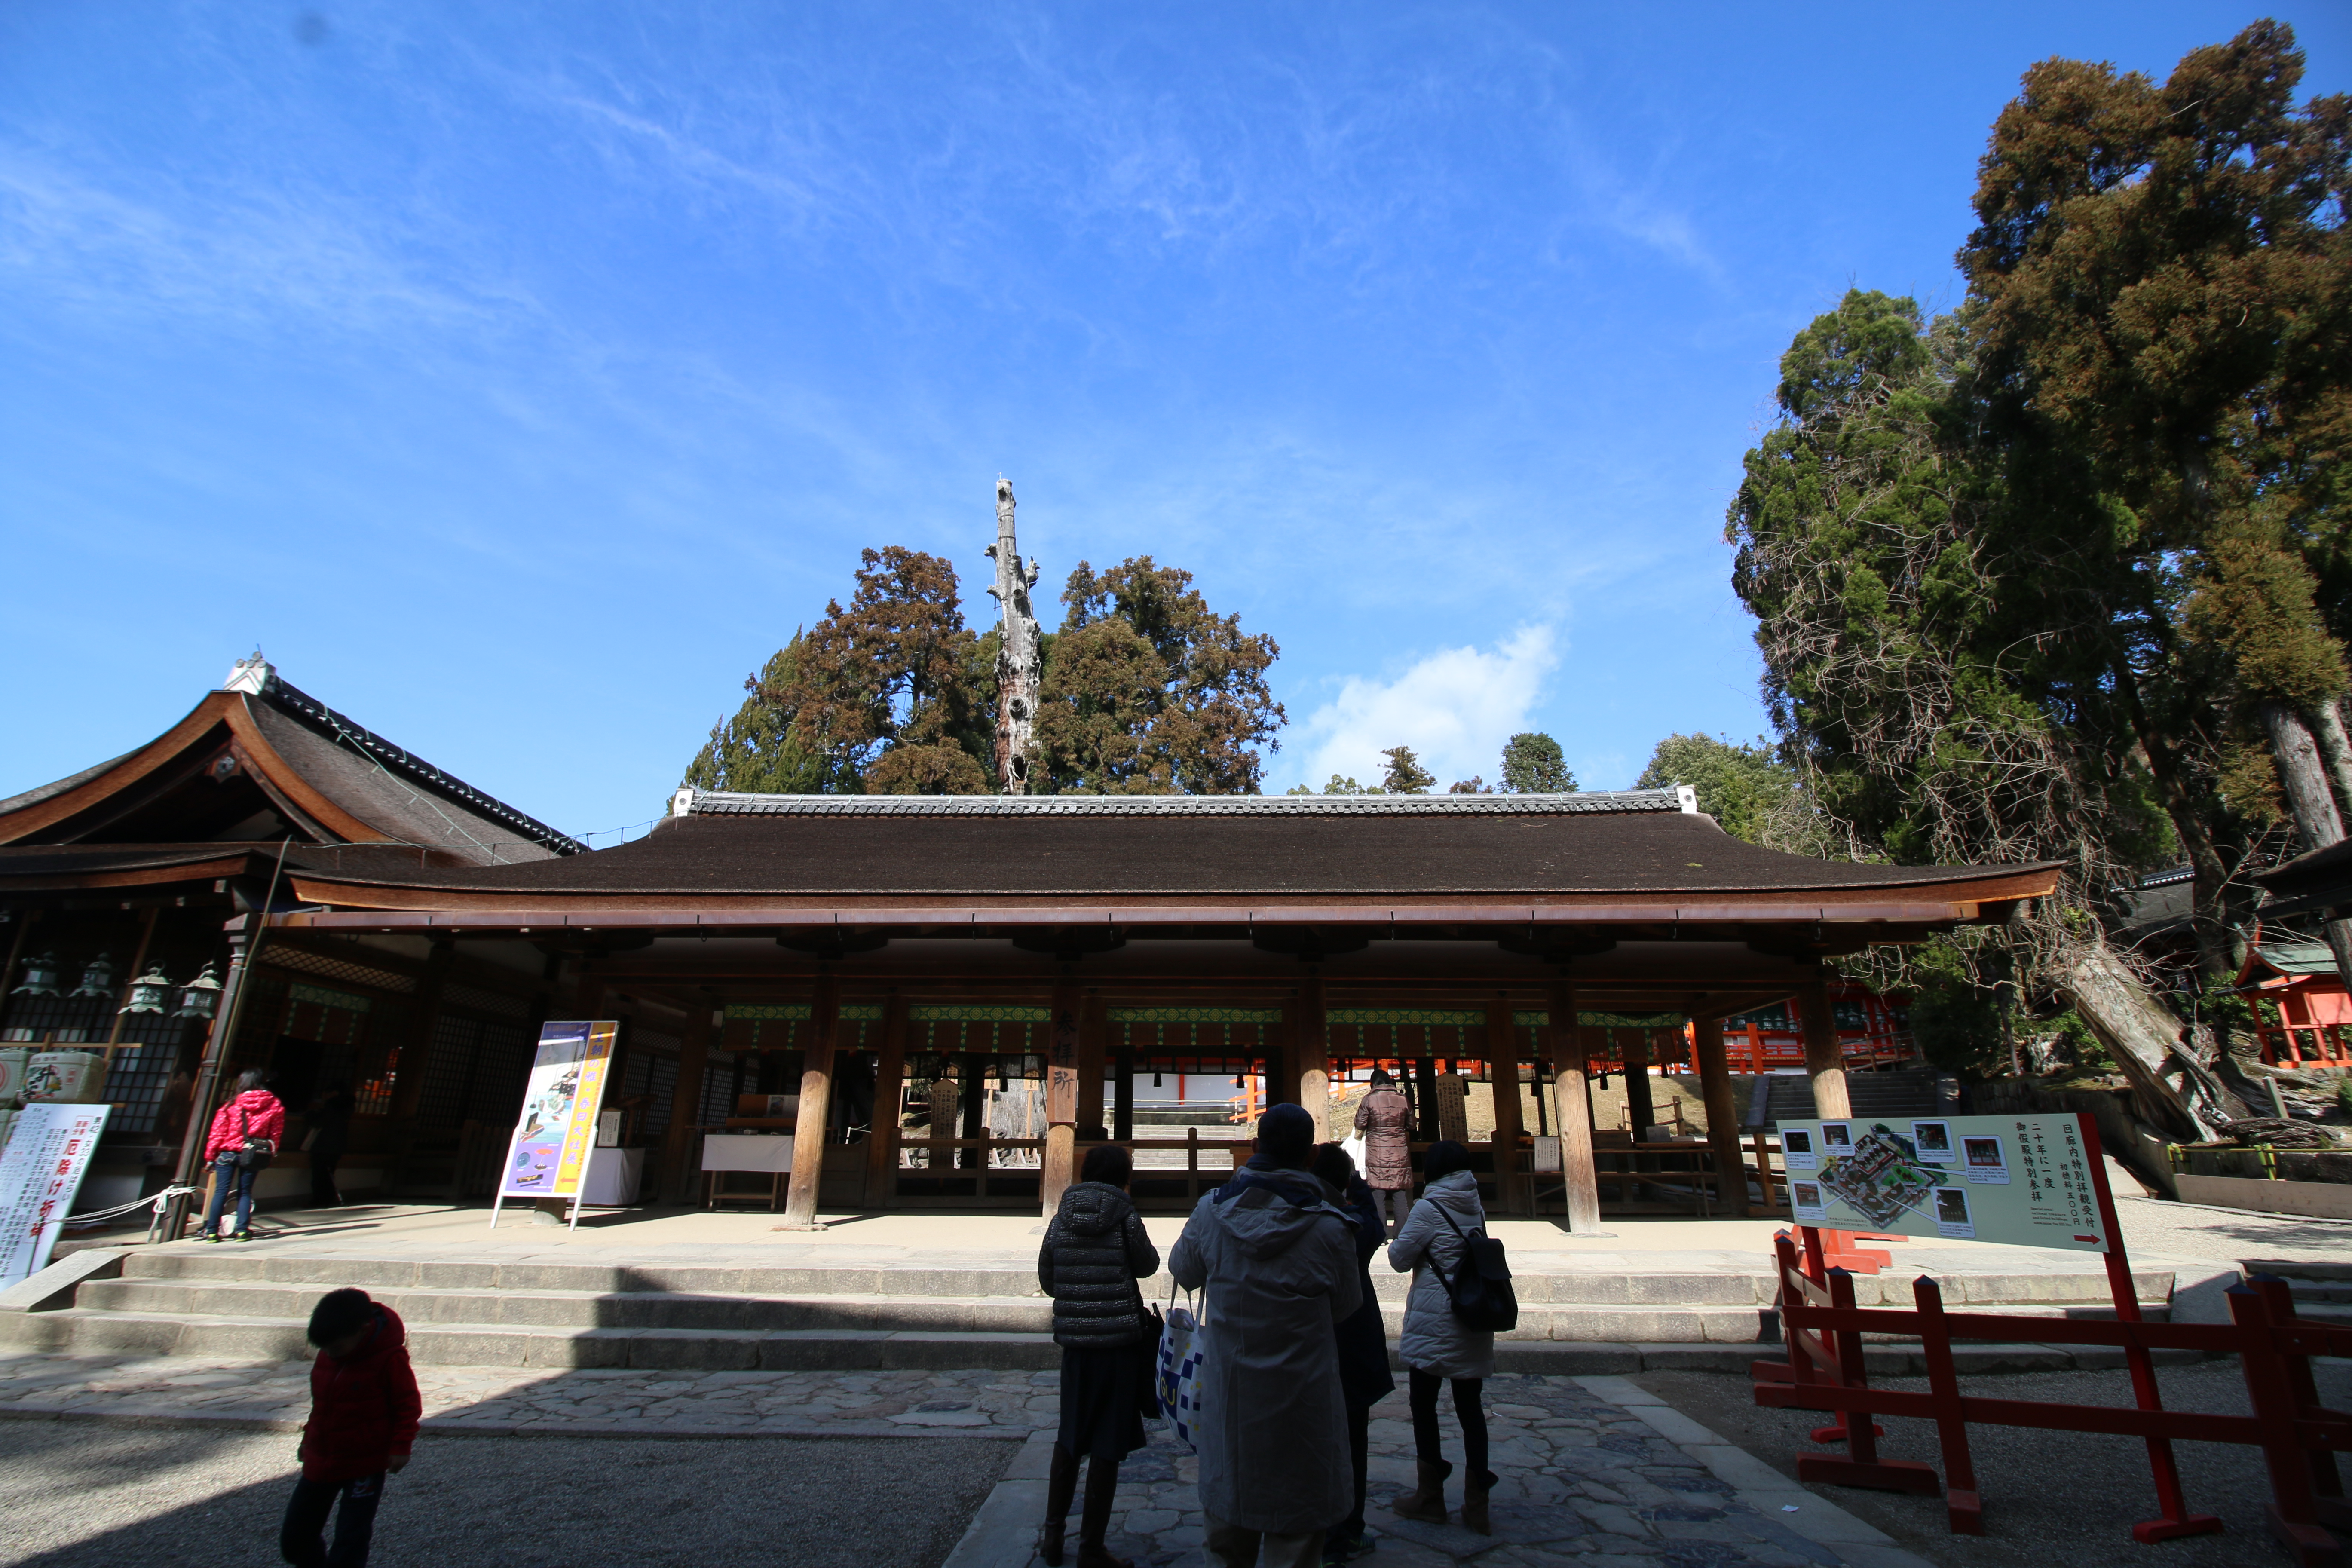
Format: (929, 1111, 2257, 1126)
(0, 1243, 2173, 1373)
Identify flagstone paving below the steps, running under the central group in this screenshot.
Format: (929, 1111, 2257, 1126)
(0, 1357, 1919, 1568)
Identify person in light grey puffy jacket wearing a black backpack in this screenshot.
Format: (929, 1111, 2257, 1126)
(1387, 1138, 1496, 1535)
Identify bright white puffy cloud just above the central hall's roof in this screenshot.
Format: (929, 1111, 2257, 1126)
(1286, 625, 1559, 787)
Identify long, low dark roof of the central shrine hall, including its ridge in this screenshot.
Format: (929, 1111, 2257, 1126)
(275, 790, 2056, 922)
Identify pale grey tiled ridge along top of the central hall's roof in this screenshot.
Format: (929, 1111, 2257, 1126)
(680, 787, 1694, 816)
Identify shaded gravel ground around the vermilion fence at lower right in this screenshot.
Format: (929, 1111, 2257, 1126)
(1628, 1361, 2352, 1568)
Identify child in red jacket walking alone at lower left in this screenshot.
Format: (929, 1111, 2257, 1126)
(278, 1291, 423, 1568)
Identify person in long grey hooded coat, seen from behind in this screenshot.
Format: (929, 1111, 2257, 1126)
(1169, 1105, 1362, 1568)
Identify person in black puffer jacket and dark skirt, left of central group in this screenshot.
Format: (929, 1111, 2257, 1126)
(1037, 1142, 1160, 1568)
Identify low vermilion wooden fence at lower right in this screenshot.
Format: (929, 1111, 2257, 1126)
(1750, 1229, 2352, 1568)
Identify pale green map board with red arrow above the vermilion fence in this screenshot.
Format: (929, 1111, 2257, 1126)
(1780, 1114, 2114, 1253)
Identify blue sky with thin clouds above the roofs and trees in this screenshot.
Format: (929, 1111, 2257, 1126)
(0, 0, 2352, 842)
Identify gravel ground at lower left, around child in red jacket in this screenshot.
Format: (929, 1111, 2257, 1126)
(0, 1420, 1018, 1568)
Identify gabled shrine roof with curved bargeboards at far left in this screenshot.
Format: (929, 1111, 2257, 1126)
(0, 661, 586, 888)
